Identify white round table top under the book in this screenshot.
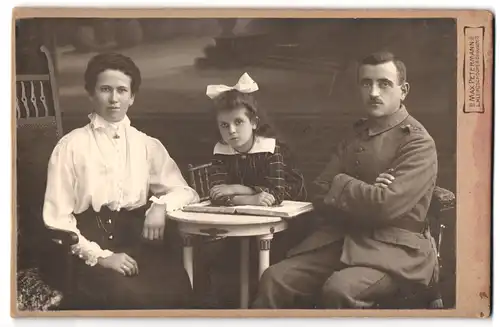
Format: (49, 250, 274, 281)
(167, 210, 283, 225)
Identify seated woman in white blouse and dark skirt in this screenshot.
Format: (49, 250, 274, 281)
(43, 53, 199, 310)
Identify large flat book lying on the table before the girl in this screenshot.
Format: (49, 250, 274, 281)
(182, 200, 313, 218)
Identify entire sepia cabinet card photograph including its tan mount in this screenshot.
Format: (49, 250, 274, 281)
(11, 8, 492, 317)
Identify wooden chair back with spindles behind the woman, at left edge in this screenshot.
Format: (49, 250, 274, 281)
(15, 46, 63, 270)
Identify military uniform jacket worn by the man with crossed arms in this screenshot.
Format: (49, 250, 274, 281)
(290, 106, 438, 284)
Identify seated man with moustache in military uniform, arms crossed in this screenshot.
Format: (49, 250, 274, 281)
(253, 52, 438, 308)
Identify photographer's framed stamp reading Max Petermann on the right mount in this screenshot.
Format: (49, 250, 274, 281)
(464, 27, 484, 113)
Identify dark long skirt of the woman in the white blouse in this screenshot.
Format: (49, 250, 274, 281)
(72, 207, 193, 310)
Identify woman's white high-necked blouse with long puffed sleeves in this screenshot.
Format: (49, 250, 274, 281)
(43, 113, 199, 266)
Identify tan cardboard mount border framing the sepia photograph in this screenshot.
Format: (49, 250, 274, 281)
(11, 7, 494, 318)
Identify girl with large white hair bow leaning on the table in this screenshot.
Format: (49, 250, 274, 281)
(207, 73, 307, 206)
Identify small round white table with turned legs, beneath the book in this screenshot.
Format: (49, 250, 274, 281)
(168, 210, 287, 309)
